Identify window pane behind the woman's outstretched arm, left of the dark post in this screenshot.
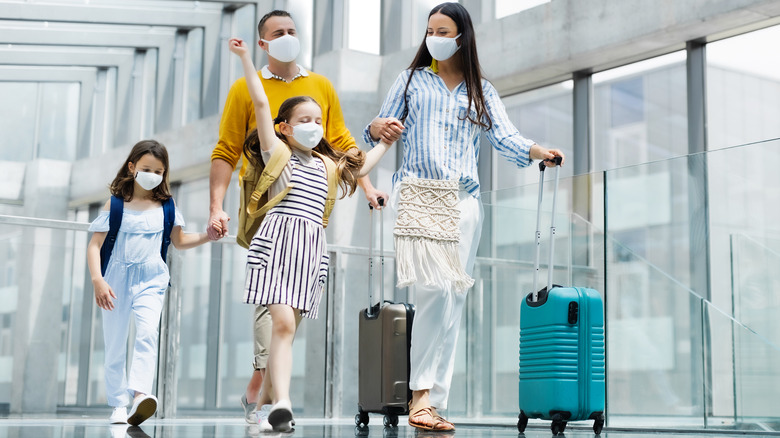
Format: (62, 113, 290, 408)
(496, 81, 573, 190)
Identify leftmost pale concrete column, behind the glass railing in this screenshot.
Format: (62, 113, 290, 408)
(11, 159, 71, 414)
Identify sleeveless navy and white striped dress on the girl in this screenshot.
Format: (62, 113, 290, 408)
(244, 154, 329, 319)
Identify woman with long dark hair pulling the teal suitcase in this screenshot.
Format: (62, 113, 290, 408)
(364, 3, 563, 431)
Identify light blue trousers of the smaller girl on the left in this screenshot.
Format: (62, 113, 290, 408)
(102, 260, 168, 407)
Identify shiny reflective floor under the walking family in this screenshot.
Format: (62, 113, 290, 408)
(0, 416, 766, 438)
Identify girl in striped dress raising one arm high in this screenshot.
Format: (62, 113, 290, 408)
(229, 38, 397, 431)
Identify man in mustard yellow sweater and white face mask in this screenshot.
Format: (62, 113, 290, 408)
(208, 10, 388, 426)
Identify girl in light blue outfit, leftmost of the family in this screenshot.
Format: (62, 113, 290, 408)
(87, 140, 218, 426)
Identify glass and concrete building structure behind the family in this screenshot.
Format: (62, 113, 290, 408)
(0, 0, 780, 431)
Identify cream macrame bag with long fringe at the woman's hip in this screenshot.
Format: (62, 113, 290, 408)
(393, 177, 474, 292)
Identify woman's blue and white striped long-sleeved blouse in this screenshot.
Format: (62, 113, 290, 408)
(363, 67, 534, 198)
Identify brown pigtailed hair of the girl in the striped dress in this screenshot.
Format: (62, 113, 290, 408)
(244, 96, 366, 198)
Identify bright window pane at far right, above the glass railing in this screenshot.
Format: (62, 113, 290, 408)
(707, 26, 780, 150)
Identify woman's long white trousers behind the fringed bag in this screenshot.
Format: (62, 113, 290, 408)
(390, 184, 484, 409)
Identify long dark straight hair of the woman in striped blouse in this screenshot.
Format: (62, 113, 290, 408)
(401, 2, 493, 129)
